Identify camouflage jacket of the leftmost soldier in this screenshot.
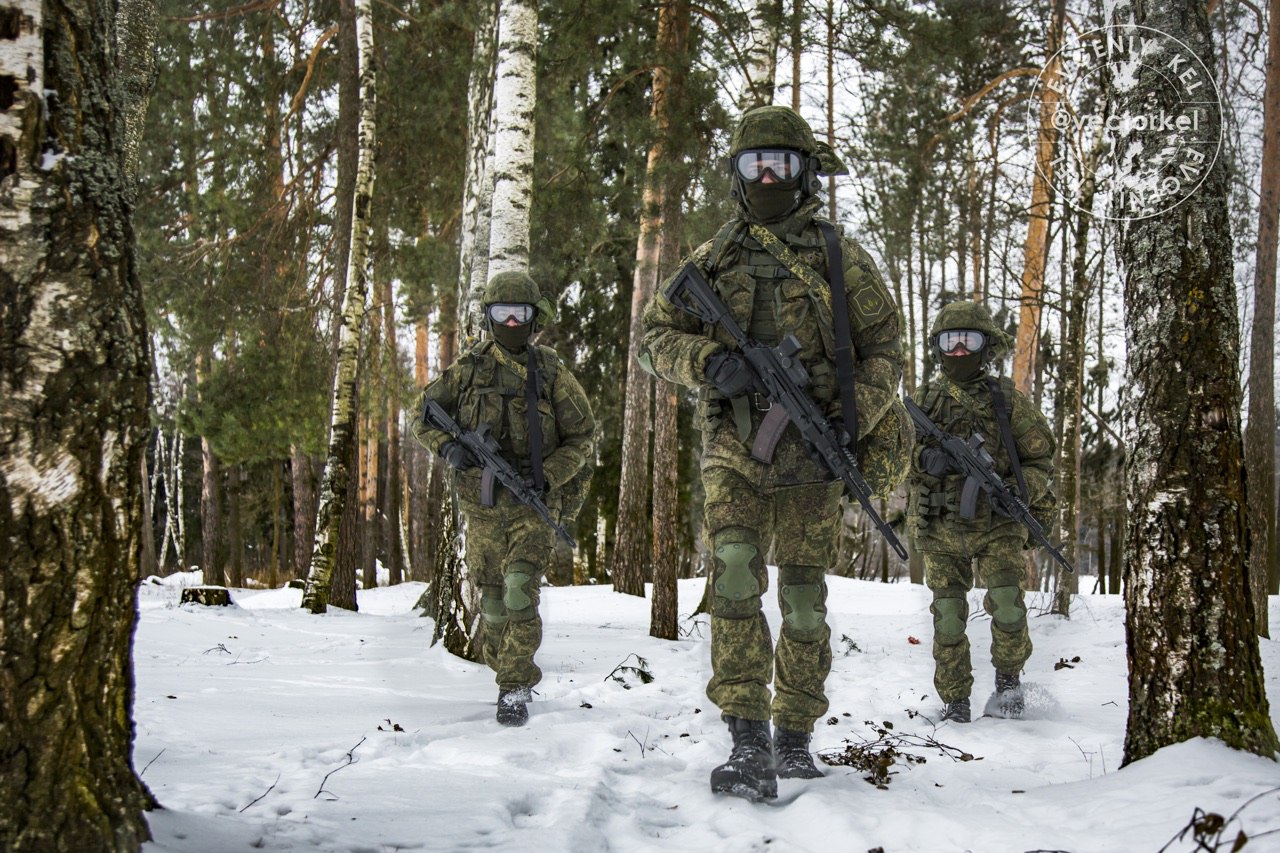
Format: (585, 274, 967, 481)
(413, 339, 595, 501)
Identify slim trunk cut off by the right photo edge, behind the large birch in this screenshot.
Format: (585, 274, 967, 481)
(1244, 0, 1280, 637)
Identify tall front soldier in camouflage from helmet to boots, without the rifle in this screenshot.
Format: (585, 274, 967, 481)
(640, 106, 914, 799)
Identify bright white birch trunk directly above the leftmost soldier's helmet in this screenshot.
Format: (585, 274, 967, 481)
(489, 0, 538, 277)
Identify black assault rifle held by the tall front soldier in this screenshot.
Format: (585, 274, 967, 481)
(663, 263, 906, 560)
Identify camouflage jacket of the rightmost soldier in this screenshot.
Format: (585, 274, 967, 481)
(908, 371, 1056, 537)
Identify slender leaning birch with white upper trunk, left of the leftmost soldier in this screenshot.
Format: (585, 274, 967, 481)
(302, 0, 376, 613)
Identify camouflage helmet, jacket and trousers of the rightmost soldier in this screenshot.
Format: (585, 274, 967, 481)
(908, 301, 1055, 702)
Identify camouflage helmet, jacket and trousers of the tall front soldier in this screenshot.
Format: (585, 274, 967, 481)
(640, 108, 914, 731)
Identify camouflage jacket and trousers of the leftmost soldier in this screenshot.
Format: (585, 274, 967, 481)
(413, 326, 595, 689)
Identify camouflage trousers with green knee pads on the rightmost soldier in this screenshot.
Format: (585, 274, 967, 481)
(918, 537, 1032, 702)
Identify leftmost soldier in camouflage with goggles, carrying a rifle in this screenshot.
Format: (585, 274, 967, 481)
(413, 272, 595, 726)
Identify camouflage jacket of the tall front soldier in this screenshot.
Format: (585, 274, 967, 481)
(640, 199, 904, 479)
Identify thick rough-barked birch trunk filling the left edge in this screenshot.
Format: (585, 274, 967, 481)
(0, 0, 155, 852)
